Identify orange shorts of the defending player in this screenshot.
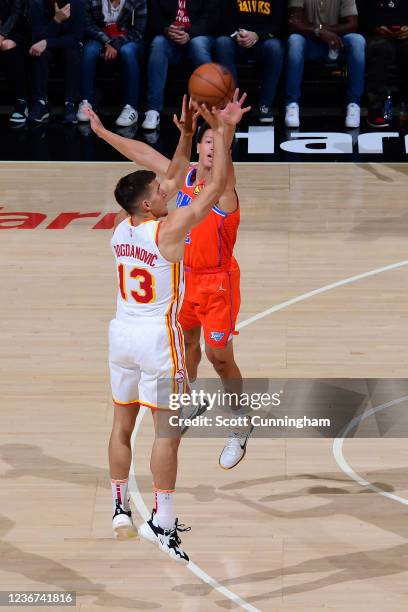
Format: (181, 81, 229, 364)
(179, 261, 241, 348)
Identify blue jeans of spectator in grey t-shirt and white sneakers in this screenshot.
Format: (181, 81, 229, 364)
(285, 34, 366, 104)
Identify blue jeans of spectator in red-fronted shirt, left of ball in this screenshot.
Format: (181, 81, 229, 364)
(147, 35, 213, 112)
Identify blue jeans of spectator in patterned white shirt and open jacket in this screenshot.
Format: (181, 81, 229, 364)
(81, 40, 143, 108)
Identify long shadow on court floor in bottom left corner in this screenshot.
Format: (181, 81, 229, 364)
(0, 516, 162, 610)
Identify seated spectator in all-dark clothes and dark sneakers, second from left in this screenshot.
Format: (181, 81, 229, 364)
(28, 0, 85, 124)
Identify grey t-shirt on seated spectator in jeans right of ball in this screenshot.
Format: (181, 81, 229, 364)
(289, 0, 358, 26)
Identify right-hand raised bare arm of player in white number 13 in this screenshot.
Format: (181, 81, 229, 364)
(159, 105, 229, 261)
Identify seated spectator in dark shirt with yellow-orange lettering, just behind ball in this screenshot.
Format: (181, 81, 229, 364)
(214, 0, 287, 123)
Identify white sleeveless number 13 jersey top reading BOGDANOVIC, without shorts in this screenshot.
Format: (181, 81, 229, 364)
(111, 218, 184, 324)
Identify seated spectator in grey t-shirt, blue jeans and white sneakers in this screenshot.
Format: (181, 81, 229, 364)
(285, 0, 365, 128)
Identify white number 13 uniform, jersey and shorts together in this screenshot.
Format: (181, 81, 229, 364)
(109, 219, 187, 409)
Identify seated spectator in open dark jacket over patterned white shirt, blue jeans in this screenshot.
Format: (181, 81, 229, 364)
(77, 0, 147, 127)
